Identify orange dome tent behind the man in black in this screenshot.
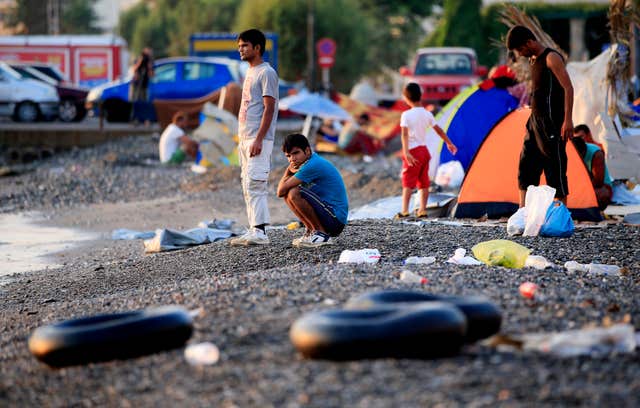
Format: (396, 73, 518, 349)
(453, 108, 602, 221)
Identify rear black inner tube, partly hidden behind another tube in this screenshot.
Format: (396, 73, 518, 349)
(345, 290, 502, 344)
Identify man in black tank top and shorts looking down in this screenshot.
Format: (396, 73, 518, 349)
(507, 26, 573, 207)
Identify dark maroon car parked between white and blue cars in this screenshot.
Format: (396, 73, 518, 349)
(9, 62, 89, 122)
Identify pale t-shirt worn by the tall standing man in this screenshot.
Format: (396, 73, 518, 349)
(238, 62, 278, 140)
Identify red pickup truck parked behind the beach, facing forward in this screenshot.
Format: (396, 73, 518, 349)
(400, 47, 487, 105)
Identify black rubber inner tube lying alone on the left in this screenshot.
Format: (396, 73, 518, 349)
(29, 306, 193, 367)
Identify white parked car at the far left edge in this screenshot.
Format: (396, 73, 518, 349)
(0, 62, 60, 122)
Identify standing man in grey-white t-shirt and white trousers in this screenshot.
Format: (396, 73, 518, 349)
(231, 29, 278, 246)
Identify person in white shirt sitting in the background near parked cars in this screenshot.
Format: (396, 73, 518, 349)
(158, 111, 198, 164)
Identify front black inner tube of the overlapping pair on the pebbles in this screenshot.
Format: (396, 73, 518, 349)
(289, 302, 466, 360)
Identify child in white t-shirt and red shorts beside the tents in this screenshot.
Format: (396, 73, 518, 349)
(395, 82, 458, 219)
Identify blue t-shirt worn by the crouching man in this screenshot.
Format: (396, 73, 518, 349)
(294, 153, 349, 224)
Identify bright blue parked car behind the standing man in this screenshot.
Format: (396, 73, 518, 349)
(86, 57, 243, 121)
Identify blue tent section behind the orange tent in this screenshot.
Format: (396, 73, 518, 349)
(440, 87, 518, 172)
